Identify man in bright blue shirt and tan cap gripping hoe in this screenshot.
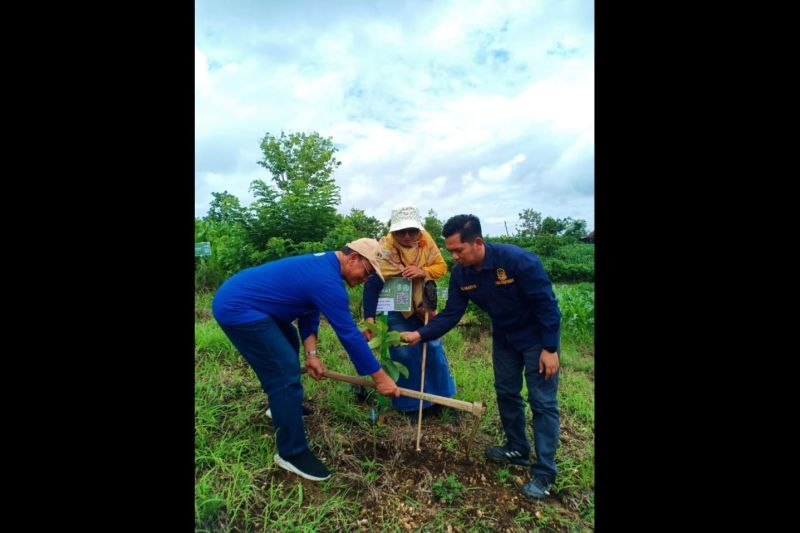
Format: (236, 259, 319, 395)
(212, 239, 400, 481)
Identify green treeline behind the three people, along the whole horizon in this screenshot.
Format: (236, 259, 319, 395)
(195, 132, 594, 290)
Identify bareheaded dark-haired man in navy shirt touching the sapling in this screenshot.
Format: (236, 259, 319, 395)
(401, 215, 561, 498)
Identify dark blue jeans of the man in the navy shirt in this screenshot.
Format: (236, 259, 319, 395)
(492, 339, 560, 482)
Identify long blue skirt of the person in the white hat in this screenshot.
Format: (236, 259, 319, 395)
(389, 311, 456, 411)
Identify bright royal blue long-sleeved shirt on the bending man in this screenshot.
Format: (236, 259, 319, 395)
(212, 252, 381, 376)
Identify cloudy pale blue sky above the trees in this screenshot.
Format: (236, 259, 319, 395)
(195, 0, 594, 235)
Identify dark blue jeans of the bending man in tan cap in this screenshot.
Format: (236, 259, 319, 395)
(220, 318, 308, 458)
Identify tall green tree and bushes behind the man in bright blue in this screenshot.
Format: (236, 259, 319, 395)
(195, 132, 346, 287)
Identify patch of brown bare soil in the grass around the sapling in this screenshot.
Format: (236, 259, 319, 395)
(271, 411, 577, 531)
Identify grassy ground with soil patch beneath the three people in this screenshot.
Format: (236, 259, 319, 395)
(195, 283, 594, 532)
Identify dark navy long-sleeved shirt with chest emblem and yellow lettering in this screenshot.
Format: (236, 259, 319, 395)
(418, 243, 561, 351)
